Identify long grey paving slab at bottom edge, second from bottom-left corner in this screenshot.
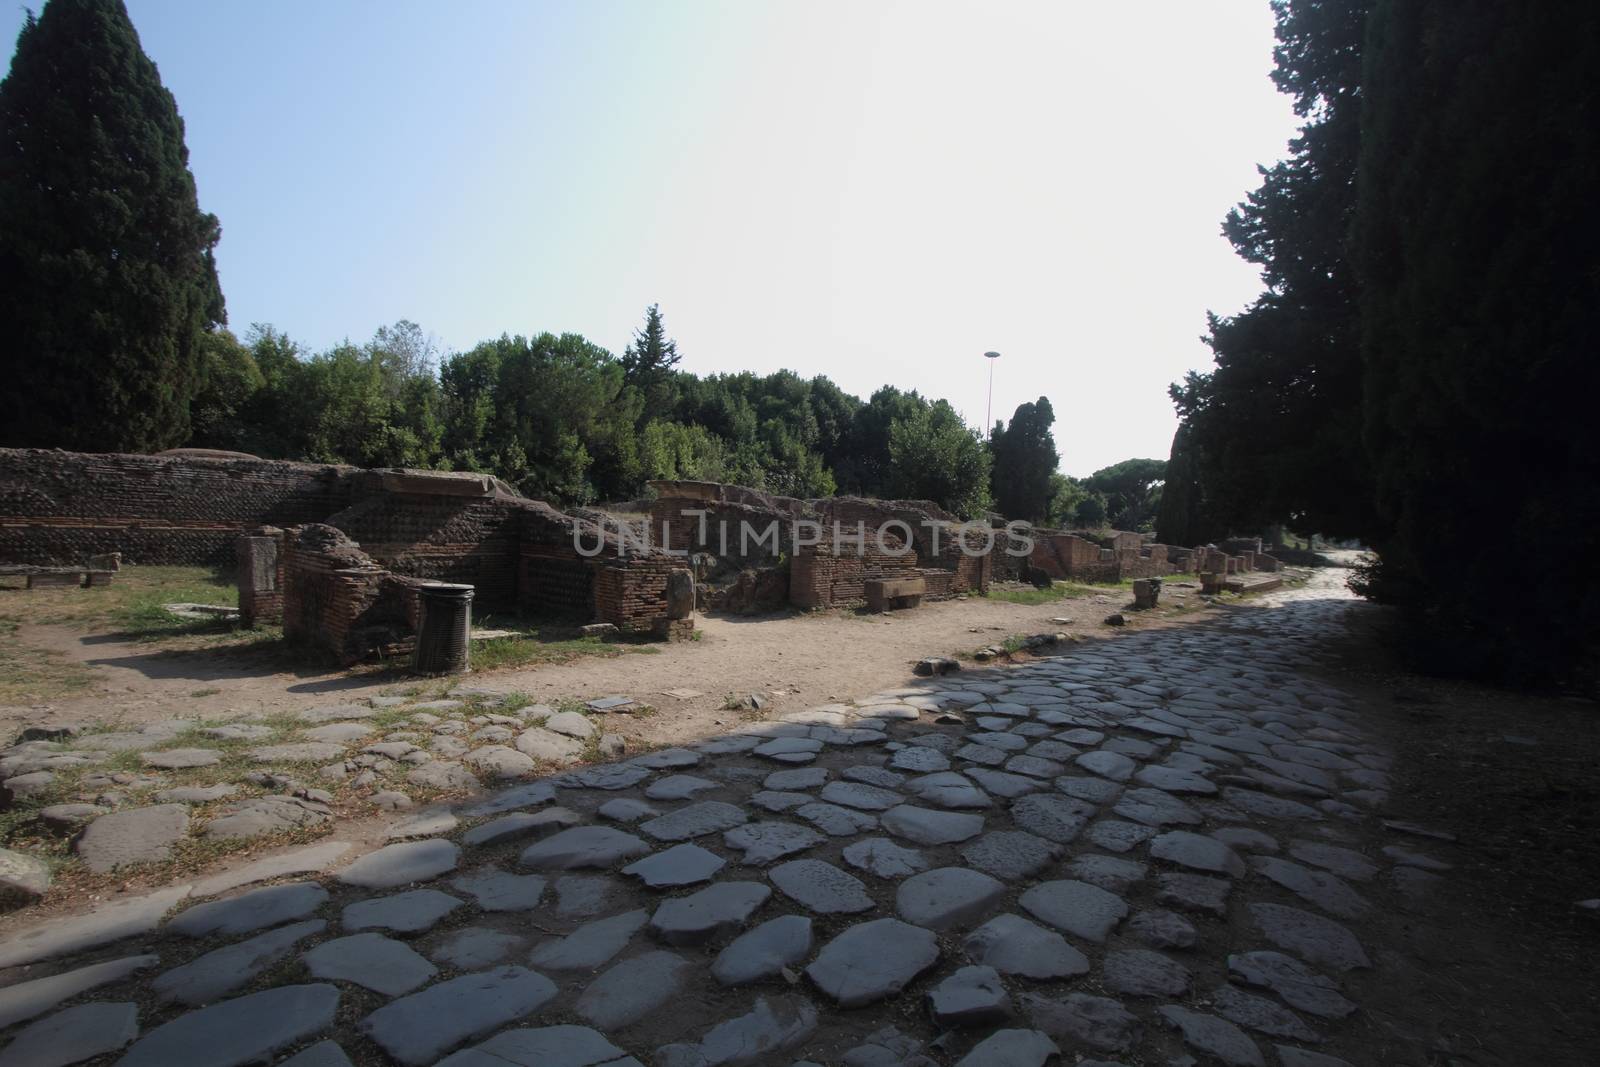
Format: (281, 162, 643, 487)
(117, 982, 339, 1067)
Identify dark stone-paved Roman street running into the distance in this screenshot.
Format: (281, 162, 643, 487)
(0, 571, 1453, 1067)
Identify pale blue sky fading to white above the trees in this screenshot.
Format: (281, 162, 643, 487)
(0, 0, 1294, 475)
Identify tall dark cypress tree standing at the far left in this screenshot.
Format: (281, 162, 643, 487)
(0, 0, 226, 451)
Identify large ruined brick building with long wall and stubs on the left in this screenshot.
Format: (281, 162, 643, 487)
(0, 450, 694, 662)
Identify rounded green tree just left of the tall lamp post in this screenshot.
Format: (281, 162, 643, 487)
(890, 400, 990, 518)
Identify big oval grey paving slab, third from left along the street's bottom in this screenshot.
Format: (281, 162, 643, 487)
(358, 966, 557, 1067)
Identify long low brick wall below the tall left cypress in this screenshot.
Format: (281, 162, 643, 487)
(0, 448, 355, 566)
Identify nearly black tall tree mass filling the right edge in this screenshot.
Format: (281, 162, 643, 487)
(1355, 0, 1600, 691)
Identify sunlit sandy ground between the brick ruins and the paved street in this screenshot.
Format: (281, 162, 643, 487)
(0, 584, 1213, 744)
